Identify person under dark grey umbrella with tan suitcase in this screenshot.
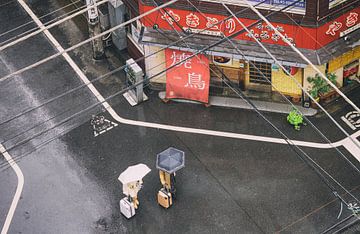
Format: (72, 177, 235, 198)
(156, 147, 185, 208)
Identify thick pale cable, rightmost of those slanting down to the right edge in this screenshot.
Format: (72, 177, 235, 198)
(243, 0, 360, 113)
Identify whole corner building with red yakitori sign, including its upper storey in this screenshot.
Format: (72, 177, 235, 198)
(124, 0, 360, 103)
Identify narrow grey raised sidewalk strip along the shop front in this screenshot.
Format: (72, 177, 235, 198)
(159, 92, 317, 116)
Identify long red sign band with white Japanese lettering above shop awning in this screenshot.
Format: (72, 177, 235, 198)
(139, 2, 360, 50)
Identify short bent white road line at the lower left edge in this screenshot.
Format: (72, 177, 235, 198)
(0, 144, 24, 234)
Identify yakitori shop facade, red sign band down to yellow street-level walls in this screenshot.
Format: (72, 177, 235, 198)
(124, 1, 360, 102)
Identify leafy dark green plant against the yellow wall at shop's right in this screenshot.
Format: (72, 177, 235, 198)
(307, 73, 336, 98)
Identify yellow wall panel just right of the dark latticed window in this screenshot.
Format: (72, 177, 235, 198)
(271, 68, 303, 97)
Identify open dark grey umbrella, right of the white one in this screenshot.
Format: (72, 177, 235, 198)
(156, 147, 185, 174)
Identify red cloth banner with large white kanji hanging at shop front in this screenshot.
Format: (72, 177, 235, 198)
(165, 49, 210, 103)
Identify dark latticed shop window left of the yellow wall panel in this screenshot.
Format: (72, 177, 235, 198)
(249, 62, 271, 84)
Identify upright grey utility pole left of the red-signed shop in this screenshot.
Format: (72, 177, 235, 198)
(86, 0, 104, 60)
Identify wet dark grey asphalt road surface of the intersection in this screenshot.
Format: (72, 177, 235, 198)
(0, 1, 360, 233)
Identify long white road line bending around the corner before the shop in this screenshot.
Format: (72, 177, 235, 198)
(18, 0, 360, 157)
